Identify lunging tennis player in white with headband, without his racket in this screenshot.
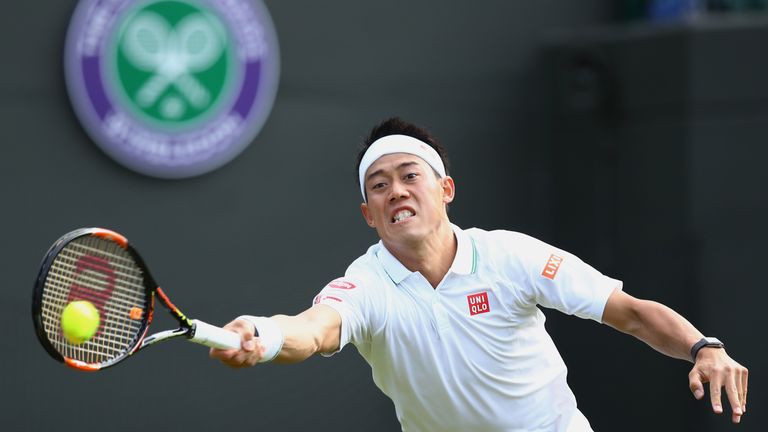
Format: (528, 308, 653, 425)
(211, 118, 747, 432)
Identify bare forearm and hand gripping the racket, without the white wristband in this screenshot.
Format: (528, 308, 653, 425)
(210, 305, 341, 368)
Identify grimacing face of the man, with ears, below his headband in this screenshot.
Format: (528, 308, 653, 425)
(360, 153, 455, 243)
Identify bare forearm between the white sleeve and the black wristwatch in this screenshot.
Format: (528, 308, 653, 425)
(622, 300, 703, 361)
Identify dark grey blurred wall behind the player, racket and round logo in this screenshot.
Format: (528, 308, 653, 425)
(0, 0, 768, 432)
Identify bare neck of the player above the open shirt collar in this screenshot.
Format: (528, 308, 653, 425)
(384, 220, 458, 288)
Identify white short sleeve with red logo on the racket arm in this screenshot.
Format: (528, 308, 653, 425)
(312, 276, 369, 356)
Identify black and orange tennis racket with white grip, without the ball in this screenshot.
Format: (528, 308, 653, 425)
(32, 228, 240, 371)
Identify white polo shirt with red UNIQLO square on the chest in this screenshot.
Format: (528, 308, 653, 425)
(314, 225, 622, 432)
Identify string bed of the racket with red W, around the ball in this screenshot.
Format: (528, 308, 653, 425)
(42, 236, 150, 364)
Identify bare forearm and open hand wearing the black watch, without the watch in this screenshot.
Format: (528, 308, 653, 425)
(603, 290, 748, 423)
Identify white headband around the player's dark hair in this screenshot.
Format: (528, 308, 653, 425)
(358, 135, 445, 202)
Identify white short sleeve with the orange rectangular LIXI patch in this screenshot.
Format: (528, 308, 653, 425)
(507, 233, 623, 322)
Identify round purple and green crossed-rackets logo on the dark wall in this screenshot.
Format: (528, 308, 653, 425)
(65, 0, 279, 178)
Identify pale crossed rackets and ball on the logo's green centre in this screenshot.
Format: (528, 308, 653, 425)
(122, 11, 226, 120)
